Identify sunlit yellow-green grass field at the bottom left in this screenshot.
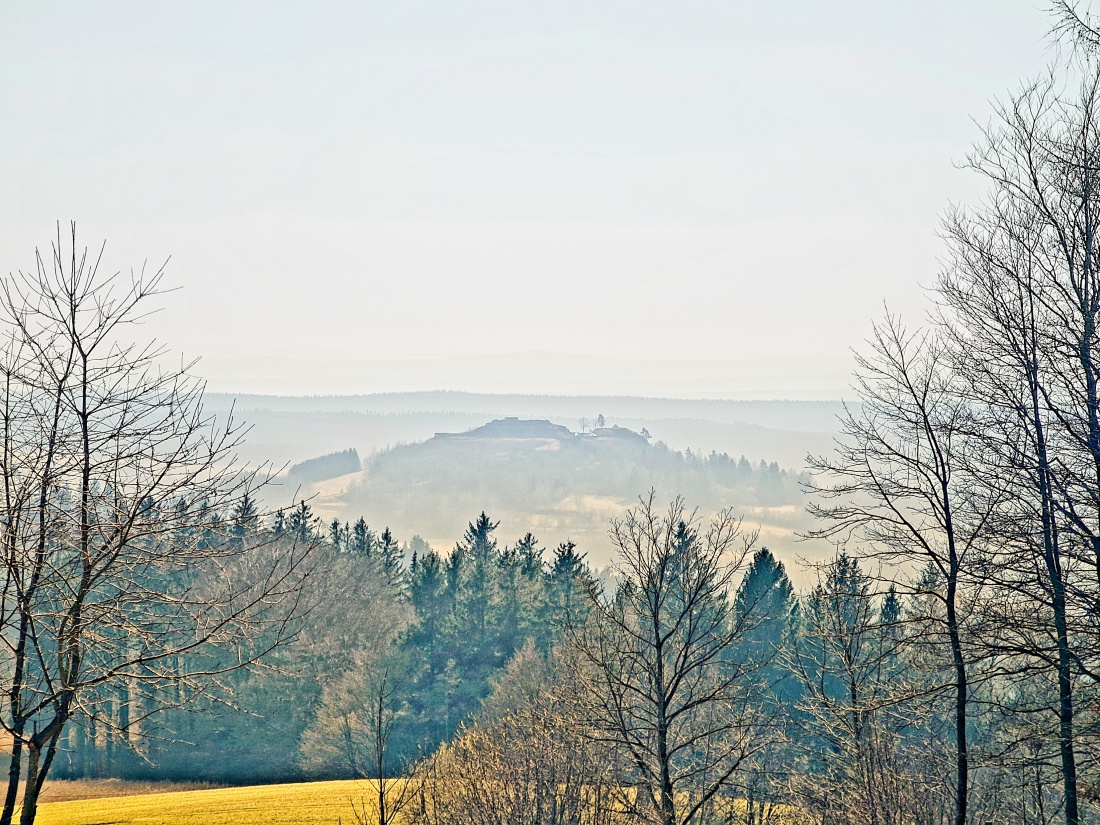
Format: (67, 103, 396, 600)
(36, 780, 378, 825)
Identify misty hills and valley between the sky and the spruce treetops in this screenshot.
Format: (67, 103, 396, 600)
(208, 392, 843, 581)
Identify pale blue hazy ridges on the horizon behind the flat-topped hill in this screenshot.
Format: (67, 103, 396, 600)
(208, 392, 843, 470)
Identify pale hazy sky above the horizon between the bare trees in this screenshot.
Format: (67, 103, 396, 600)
(0, 0, 1054, 397)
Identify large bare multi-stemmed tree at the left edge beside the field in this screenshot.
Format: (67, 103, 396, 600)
(0, 227, 309, 825)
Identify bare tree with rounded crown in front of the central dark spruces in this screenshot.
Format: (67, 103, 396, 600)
(568, 494, 760, 825)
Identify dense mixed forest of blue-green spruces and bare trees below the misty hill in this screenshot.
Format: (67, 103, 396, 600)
(40, 484, 1100, 823)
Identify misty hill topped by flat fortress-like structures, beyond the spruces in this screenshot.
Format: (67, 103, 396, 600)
(284, 418, 809, 565)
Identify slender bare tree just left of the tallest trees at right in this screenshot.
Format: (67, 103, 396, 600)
(810, 316, 998, 825)
